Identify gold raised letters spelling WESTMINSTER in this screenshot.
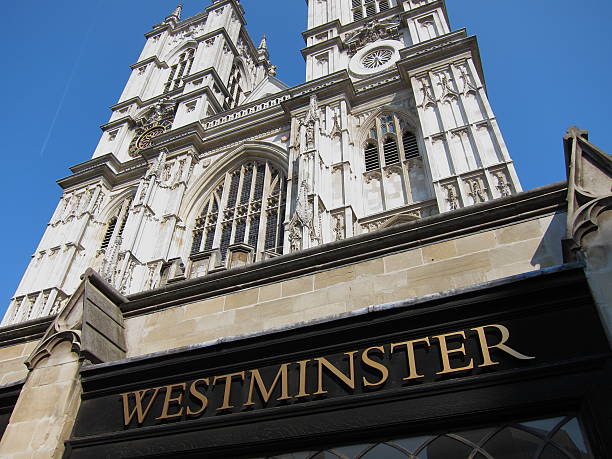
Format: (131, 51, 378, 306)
(118, 324, 535, 427)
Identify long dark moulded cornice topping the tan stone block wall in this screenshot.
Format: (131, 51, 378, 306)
(122, 182, 567, 317)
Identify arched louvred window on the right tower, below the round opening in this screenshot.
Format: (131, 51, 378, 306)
(363, 113, 427, 214)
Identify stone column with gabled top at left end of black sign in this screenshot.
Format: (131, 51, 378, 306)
(0, 268, 127, 459)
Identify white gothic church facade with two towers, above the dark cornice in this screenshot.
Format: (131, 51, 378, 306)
(2, 0, 521, 325)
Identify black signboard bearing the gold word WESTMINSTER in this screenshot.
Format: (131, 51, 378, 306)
(65, 270, 610, 459)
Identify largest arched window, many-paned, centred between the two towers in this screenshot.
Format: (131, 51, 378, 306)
(191, 161, 287, 260)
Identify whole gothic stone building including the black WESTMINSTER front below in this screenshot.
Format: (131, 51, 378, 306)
(0, 0, 612, 459)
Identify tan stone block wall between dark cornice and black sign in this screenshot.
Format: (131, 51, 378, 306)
(126, 210, 565, 356)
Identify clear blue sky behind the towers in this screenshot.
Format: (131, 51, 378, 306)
(0, 0, 612, 322)
